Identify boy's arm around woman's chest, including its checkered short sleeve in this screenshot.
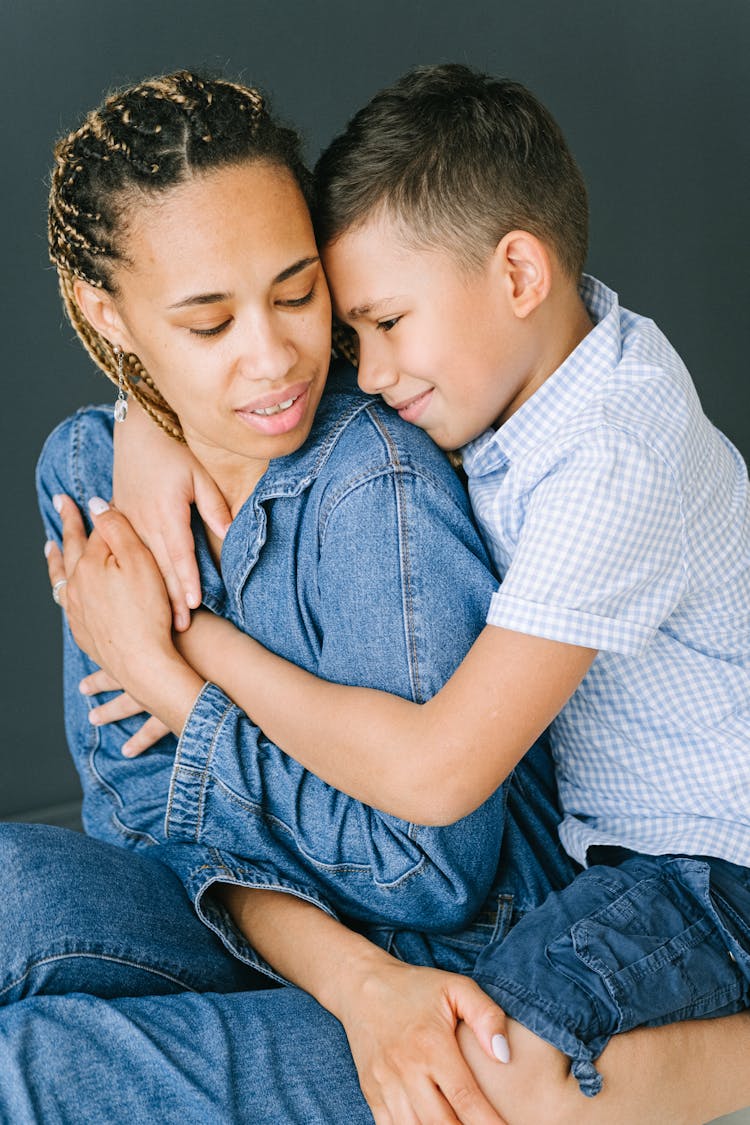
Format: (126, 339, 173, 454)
(172, 433, 685, 825)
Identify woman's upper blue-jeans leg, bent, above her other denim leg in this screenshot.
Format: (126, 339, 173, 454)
(0, 824, 268, 1005)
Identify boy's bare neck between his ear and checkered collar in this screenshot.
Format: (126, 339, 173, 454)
(496, 285, 594, 428)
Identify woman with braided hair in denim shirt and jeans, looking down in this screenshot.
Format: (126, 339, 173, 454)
(7, 75, 750, 1121)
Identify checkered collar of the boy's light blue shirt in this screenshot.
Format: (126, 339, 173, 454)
(462, 273, 622, 477)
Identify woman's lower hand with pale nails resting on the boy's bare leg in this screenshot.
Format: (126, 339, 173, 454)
(332, 961, 509, 1125)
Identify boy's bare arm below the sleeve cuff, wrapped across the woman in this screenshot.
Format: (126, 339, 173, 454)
(179, 613, 596, 825)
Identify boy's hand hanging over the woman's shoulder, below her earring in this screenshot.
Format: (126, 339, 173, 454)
(114, 403, 232, 631)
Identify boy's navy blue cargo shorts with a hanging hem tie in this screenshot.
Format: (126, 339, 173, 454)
(473, 848, 750, 1096)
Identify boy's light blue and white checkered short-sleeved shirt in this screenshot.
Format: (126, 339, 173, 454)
(463, 278, 750, 866)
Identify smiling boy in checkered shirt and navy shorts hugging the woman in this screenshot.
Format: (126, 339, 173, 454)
(93, 65, 750, 1094)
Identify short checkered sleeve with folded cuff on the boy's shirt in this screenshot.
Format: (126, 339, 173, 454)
(487, 428, 685, 655)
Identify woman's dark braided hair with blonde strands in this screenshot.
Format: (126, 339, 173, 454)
(48, 71, 311, 441)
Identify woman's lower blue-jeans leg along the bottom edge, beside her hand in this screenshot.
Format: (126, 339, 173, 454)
(0, 988, 372, 1125)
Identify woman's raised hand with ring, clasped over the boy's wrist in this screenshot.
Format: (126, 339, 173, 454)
(45, 496, 202, 734)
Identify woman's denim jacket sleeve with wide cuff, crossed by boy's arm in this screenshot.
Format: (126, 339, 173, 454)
(168, 460, 505, 933)
